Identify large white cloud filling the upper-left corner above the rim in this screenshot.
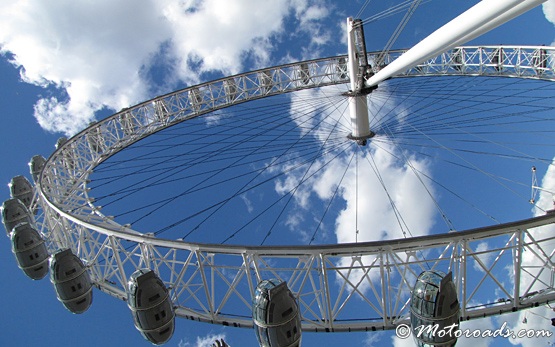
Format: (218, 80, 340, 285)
(0, 0, 168, 134)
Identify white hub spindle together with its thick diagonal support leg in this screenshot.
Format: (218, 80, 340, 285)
(347, 0, 546, 145)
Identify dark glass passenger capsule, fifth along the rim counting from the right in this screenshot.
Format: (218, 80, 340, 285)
(12, 223, 48, 280)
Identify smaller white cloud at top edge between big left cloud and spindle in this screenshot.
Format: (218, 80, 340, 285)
(161, 0, 289, 80)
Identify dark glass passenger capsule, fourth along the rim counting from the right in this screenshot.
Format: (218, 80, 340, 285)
(50, 248, 92, 313)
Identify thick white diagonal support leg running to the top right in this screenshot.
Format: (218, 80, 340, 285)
(366, 0, 546, 87)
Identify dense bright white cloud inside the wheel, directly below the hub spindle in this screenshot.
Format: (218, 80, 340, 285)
(336, 143, 435, 243)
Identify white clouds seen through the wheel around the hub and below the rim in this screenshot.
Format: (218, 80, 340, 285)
(275, 88, 437, 291)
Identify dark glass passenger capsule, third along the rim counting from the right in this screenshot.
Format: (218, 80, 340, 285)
(127, 269, 175, 345)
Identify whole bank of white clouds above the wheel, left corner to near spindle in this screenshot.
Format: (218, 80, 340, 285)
(0, 0, 329, 135)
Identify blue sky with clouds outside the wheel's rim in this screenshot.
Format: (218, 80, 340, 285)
(0, 0, 555, 347)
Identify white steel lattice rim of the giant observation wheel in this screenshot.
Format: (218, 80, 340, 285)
(35, 46, 555, 331)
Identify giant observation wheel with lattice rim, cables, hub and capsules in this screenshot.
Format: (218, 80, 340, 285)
(3, 1, 555, 343)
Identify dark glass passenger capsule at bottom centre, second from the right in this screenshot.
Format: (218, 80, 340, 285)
(252, 279, 301, 347)
